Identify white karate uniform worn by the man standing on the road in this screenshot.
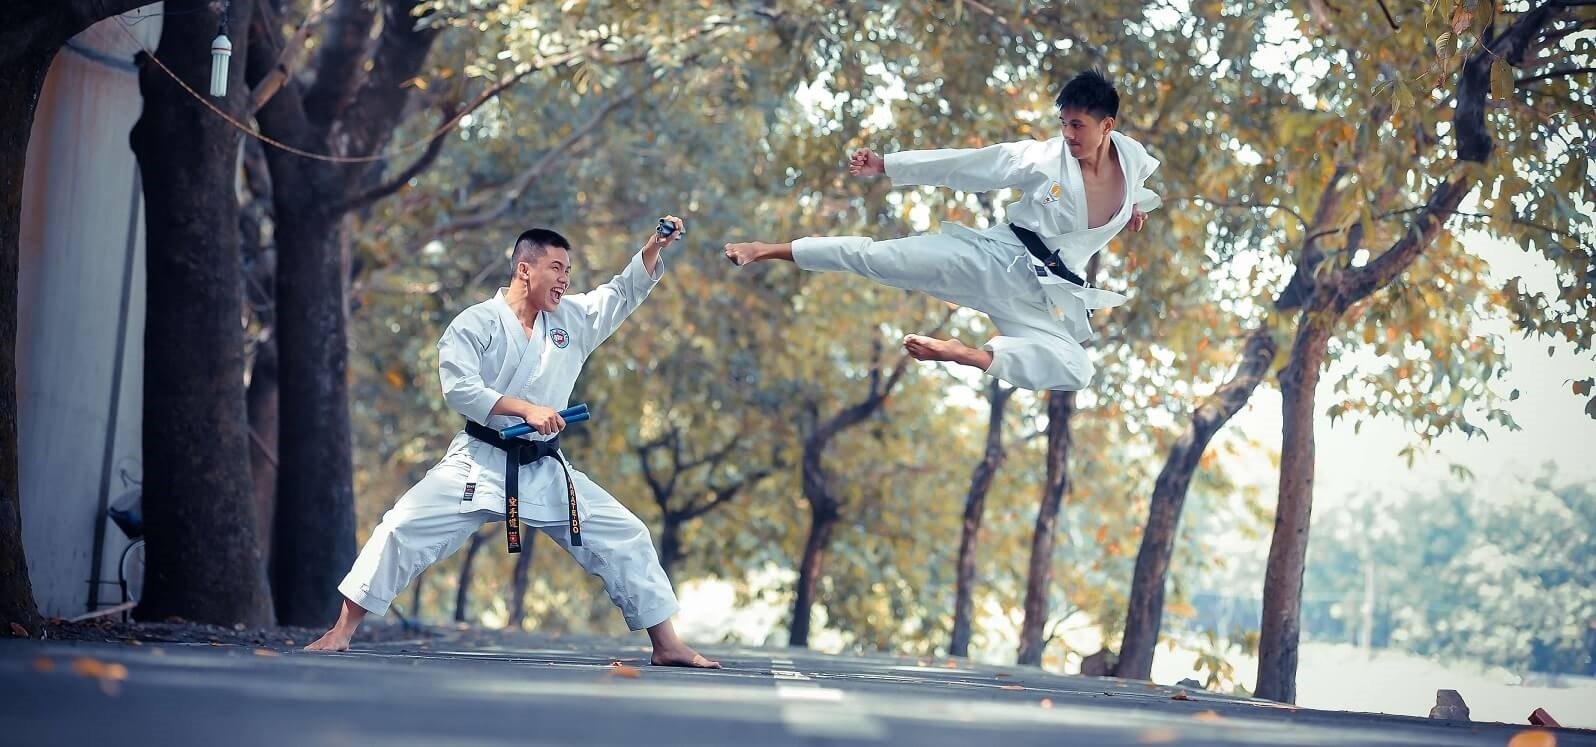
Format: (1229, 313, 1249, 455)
(338, 254, 678, 630)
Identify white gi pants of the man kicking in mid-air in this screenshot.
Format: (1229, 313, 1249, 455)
(793, 233, 1095, 391)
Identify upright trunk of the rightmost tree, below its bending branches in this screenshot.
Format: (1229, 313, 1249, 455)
(1254, 306, 1336, 702)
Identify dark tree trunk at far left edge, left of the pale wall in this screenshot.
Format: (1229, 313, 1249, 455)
(0, 49, 54, 635)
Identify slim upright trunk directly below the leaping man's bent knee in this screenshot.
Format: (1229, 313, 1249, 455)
(1018, 391, 1076, 667)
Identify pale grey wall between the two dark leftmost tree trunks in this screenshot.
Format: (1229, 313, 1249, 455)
(18, 5, 161, 618)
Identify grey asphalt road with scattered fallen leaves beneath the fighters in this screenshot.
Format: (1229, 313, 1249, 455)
(0, 635, 1596, 747)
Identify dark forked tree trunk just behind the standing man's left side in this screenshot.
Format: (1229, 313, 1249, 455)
(249, 0, 439, 626)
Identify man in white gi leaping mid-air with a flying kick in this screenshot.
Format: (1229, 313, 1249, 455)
(726, 72, 1159, 389)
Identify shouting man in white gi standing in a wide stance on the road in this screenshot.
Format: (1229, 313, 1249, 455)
(306, 217, 720, 669)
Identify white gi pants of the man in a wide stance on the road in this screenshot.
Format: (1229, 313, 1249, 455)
(338, 464, 678, 630)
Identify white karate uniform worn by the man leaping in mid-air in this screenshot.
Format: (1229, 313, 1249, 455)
(793, 132, 1160, 391)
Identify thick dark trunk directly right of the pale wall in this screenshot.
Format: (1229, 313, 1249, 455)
(132, 0, 271, 624)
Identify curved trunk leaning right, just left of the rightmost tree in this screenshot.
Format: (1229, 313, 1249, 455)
(1114, 327, 1275, 680)
